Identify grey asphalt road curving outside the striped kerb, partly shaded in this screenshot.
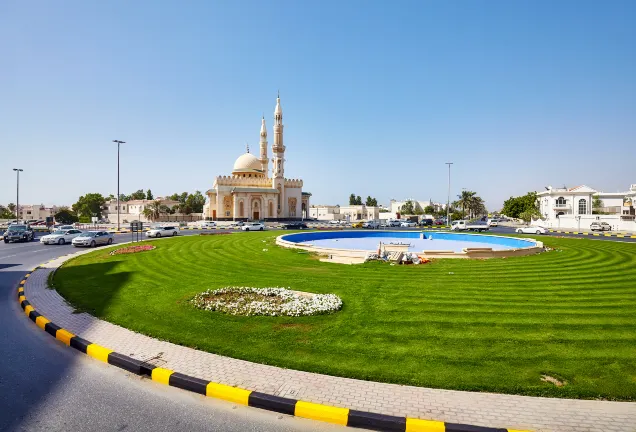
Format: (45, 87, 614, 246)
(0, 231, 343, 432)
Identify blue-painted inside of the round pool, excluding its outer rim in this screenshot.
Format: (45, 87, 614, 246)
(283, 231, 535, 252)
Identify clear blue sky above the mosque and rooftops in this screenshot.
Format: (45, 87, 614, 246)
(0, 0, 636, 209)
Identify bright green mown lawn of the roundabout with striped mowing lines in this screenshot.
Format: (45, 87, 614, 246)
(54, 232, 636, 400)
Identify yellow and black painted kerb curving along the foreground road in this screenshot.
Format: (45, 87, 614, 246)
(18, 267, 529, 432)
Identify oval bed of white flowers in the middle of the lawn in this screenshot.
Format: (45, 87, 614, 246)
(191, 287, 342, 316)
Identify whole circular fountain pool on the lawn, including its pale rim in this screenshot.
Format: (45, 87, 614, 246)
(277, 231, 543, 258)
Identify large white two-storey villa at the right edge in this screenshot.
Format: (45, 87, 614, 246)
(533, 184, 636, 231)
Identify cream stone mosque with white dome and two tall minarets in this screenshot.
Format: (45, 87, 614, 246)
(203, 95, 311, 221)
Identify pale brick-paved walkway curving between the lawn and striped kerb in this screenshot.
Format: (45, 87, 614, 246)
(25, 251, 636, 432)
